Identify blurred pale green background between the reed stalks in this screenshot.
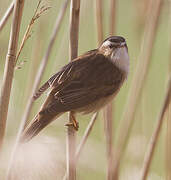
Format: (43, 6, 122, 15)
(0, 0, 171, 180)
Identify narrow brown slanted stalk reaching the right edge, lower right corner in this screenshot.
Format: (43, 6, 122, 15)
(140, 76, 171, 180)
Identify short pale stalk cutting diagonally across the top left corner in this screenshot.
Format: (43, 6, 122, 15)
(0, 1, 14, 32)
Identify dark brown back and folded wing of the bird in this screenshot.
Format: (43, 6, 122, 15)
(41, 53, 125, 114)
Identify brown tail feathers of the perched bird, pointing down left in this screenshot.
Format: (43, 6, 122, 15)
(20, 114, 60, 143)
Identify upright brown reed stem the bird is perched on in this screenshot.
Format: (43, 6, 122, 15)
(67, 0, 80, 180)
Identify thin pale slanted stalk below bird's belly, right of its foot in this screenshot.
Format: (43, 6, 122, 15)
(63, 113, 98, 180)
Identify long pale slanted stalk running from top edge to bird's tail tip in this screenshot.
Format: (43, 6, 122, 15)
(22, 0, 69, 129)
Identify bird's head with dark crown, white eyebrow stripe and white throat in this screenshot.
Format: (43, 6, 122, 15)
(99, 36, 129, 73)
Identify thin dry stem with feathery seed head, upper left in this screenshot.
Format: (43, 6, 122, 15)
(15, 0, 50, 69)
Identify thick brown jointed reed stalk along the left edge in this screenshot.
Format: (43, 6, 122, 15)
(0, 0, 24, 151)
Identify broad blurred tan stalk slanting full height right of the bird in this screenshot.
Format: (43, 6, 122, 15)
(113, 0, 162, 179)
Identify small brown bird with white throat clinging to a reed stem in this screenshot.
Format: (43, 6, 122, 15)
(20, 36, 129, 142)
